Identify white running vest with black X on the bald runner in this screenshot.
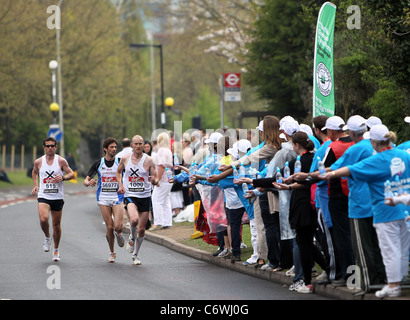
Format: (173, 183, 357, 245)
(123, 153, 152, 198)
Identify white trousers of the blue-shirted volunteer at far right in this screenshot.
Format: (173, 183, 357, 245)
(373, 219, 410, 283)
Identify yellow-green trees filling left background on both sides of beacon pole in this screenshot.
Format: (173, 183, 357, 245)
(0, 0, 154, 162)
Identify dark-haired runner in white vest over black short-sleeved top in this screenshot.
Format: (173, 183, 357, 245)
(84, 138, 124, 263)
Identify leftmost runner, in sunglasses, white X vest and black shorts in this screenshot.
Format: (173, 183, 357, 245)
(32, 137, 74, 261)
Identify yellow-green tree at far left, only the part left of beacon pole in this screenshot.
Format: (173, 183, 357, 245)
(0, 1, 52, 147)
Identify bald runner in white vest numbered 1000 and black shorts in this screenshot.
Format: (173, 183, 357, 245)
(117, 135, 158, 265)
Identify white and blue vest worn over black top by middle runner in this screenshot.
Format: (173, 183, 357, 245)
(97, 157, 124, 201)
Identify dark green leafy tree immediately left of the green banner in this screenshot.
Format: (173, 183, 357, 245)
(246, 0, 313, 118)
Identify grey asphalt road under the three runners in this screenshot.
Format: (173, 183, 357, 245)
(0, 194, 328, 301)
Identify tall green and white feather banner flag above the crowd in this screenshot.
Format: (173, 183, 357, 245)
(313, 2, 336, 117)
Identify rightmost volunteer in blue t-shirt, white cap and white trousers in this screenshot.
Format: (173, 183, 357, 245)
(325, 124, 410, 298)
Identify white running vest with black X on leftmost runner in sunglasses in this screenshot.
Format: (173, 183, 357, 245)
(37, 154, 64, 200)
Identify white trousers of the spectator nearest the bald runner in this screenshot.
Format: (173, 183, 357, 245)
(152, 181, 172, 227)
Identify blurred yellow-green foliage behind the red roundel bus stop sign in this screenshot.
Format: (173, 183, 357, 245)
(164, 22, 263, 130)
